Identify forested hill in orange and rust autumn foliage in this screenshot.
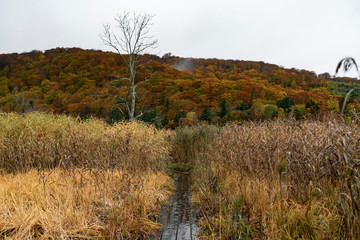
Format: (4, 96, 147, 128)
(0, 48, 360, 126)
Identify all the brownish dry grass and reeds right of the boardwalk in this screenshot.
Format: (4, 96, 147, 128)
(193, 118, 360, 239)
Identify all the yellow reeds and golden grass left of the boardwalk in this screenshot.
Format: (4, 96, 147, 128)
(0, 113, 172, 239)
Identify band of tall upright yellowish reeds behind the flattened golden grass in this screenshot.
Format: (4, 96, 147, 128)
(0, 113, 171, 172)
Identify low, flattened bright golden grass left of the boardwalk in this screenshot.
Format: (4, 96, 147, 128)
(0, 169, 172, 239)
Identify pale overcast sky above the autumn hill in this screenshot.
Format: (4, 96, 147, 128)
(0, 0, 360, 76)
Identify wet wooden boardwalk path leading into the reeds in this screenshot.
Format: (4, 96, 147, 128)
(152, 172, 198, 240)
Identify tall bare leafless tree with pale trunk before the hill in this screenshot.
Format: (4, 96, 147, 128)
(100, 12, 158, 121)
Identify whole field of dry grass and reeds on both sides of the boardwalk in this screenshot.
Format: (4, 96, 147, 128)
(0, 113, 360, 239)
